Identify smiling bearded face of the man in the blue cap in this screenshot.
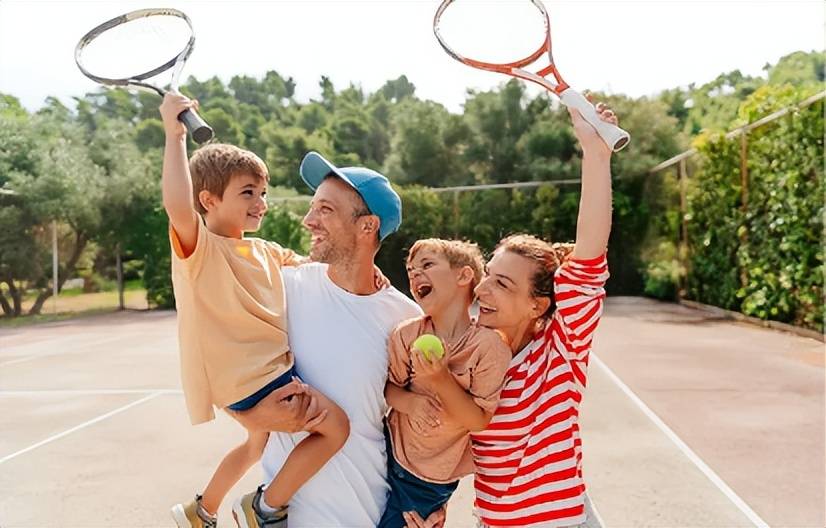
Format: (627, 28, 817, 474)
(304, 178, 361, 264)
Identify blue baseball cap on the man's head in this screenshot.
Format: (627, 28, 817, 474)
(298, 152, 402, 240)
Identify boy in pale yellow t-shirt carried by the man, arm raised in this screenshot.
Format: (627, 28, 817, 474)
(160, 93, 349, 528)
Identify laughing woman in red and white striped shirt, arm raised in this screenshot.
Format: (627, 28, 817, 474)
(406, 103, 617, 528)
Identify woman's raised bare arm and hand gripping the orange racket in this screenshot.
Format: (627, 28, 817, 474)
(569, 103, 617, 259)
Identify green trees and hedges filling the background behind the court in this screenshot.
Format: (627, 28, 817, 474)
(0, 52, 824, 327)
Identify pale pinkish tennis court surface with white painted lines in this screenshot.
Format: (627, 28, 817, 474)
(0, 298, 826, 528)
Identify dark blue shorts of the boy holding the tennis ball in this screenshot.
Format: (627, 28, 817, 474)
(377, 424, 459, 528)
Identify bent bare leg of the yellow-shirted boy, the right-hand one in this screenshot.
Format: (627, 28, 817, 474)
(264, 388, 350, 508)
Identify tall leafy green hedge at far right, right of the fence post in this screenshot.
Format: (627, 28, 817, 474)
(688, 85, 824, 331)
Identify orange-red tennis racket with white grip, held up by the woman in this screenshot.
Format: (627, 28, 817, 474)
(433, 0, 631, 152)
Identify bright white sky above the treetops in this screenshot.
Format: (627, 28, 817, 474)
(0, 0, 826, 112)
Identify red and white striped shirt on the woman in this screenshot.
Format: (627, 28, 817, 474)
(471, 255, 608, 527)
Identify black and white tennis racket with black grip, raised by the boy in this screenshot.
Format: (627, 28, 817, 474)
(75, 9, 213, 143)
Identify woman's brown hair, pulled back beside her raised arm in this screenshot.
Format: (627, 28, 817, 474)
(494, 234, 574, 317)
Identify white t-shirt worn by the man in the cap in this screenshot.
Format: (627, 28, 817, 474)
(262, 264, 421, 528)
